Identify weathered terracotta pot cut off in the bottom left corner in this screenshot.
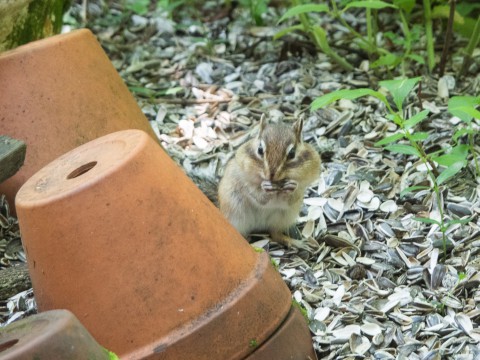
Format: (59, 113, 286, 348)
(0, 310, 109, 360)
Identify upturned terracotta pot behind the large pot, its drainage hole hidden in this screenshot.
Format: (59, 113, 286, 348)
(0, 30, 155, 212)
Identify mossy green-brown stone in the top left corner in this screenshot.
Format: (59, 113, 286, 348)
(0, 0, 70, 51)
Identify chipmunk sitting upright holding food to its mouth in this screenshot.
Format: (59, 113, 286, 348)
(218, 117, 320, 247)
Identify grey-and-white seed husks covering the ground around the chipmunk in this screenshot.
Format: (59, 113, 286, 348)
(0, 1, 480, 359)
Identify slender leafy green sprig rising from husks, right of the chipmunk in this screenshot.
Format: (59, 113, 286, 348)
(311, 77, 472, 257)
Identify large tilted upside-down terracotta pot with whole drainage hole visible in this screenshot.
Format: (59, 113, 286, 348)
(16, 130, 314, 360)
